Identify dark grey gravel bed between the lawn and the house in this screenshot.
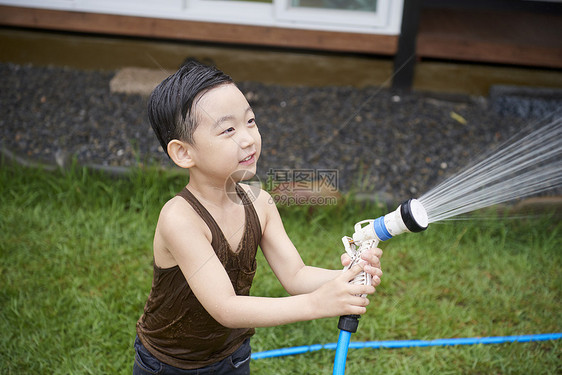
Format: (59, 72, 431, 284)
(0, 64, 560, 201)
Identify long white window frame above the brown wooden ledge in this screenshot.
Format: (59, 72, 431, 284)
(0, 0, 404, 35)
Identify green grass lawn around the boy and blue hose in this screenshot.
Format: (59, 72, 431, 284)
(0, 164, 562, 374)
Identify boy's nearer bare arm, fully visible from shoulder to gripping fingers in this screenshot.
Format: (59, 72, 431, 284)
(156, 197, 374, 328)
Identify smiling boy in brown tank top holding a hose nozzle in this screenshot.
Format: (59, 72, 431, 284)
(133, 61, 382, 374)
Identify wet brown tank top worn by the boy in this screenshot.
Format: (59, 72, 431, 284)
(137, 185, 261, 369)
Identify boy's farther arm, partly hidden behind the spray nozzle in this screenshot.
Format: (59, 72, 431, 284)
(256, 191, 382, 295)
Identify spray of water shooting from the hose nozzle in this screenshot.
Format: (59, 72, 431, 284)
(419, 114, 562, 223)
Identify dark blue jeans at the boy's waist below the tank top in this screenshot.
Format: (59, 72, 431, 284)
(133, 337, 252, 375)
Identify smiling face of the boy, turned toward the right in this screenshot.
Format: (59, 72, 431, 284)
(187, 84, 261, 186)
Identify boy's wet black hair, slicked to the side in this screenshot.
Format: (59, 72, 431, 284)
(148, 60, 234, 156)
